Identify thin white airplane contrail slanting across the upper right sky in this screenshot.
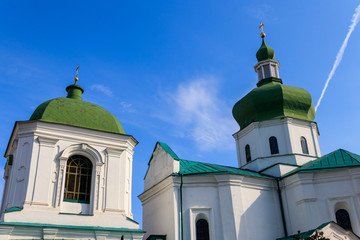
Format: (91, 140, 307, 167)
(315, 4, 360, 112)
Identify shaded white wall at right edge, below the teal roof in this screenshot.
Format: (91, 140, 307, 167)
(282, 168, 360, 235)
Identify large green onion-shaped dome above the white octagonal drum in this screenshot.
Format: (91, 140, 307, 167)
(232, 78, 315, 129)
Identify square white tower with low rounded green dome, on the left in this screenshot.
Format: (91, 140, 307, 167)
(0, 72, 145, 240)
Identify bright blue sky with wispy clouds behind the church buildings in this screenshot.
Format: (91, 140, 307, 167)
(0, 0, 360, 227)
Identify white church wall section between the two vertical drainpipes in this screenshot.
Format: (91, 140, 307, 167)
(183, 174, 283, 240)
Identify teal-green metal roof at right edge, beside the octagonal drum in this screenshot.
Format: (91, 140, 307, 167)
(283, 149, 360, 177)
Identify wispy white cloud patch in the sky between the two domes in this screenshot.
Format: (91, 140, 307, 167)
(160, 77, 237, 150)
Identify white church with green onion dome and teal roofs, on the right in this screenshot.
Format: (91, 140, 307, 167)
(139, 27, 360, 240)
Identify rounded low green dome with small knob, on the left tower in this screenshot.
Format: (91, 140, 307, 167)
(30, 84, 125, 134)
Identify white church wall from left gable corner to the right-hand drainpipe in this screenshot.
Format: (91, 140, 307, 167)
(139, 174, 283, 240)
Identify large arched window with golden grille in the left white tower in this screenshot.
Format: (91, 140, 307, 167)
(64, 155, 92, 203)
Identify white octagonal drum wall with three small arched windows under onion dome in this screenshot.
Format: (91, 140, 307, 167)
(233, 118, 321, 171)
